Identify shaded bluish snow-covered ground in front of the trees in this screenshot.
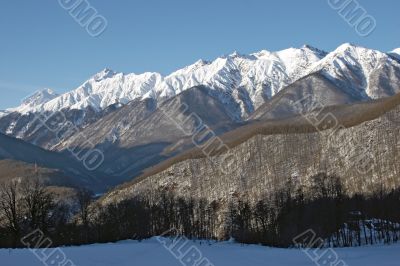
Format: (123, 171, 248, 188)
(0, 238, 400, 266)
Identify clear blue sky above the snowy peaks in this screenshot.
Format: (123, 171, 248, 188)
(0, 0, 400, 109)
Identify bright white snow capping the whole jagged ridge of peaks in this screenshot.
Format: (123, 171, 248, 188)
(7, 43, 398, 116)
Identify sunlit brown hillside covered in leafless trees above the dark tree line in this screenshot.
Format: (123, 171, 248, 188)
(103, 98, 400, 203)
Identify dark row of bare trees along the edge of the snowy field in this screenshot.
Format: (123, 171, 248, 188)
(0, 173, 400, 247)
